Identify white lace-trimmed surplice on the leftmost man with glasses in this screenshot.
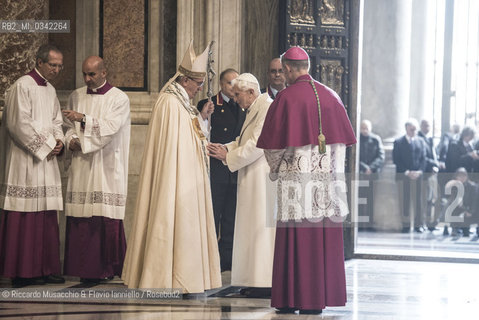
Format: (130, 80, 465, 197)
(0, 75, 64, 212)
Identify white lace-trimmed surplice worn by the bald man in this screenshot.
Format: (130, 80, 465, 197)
(65, 87, 130, 219)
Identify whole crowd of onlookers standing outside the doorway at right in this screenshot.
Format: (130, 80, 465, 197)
(359, 118, 479, 236)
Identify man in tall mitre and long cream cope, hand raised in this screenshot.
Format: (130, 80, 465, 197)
(122, 42, 221, 293)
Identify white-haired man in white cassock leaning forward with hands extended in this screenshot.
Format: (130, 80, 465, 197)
(208, 73, 276, 297)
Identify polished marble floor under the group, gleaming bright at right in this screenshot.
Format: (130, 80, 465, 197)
(0, 259, 479, 320)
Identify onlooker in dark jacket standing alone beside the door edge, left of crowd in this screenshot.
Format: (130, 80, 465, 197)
(358, 120, 384, 231)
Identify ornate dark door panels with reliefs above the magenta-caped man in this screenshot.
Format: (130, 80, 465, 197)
(280, 0, 352, 113)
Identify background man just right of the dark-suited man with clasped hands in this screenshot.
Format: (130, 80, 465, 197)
(417, 119, 440, 231)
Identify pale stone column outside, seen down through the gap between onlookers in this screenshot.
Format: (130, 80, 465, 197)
(359, 0, 413, 230)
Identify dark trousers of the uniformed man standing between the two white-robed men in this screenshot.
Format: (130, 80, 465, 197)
(211, 182, 237, 271)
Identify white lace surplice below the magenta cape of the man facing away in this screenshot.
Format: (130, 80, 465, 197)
(264, 144, 349, 221)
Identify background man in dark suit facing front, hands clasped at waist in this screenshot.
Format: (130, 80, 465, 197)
(393, 119, 426, 232)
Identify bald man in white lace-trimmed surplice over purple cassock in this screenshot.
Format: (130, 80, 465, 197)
(63, 56, 130, 283)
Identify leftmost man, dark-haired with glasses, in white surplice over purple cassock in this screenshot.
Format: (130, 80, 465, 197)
(0, 44, 65, 287)
